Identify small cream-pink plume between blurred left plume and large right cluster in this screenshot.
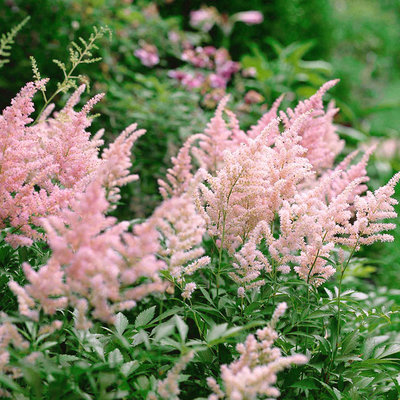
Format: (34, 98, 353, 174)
(152, 196, 210, 298)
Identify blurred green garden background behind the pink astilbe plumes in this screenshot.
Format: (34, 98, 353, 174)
(0, 0, 400, 285)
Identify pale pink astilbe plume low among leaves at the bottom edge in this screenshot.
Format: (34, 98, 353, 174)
(207, 303, 308, 400)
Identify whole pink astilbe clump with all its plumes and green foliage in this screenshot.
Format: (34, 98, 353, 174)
(0, 72, 400, 400)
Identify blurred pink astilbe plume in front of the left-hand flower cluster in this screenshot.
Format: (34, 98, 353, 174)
(10, 182, 166, 328)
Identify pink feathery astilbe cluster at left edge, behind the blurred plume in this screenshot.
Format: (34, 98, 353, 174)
(0, 80, 143, 247)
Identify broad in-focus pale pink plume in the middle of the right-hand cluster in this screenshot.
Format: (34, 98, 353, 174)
(197, 115, 312, 252)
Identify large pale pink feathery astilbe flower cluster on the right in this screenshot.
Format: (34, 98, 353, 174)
(164, 81, 399, 289)
